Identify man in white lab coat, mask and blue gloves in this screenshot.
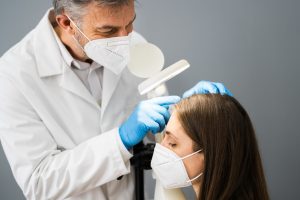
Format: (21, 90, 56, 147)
(0, 0, 229, 200)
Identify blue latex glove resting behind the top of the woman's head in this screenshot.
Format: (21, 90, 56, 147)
(183, 81, 233, 98)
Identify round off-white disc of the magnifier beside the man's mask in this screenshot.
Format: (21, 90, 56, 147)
(128, 43, 165, 78)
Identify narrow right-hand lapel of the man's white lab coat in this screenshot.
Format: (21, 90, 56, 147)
(101, 67, 122, 119)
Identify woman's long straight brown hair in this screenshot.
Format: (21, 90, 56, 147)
(175, 94, 269, 200)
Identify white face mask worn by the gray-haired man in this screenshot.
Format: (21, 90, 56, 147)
(67, 16, 131, 75)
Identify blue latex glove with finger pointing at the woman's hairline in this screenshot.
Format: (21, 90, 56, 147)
(119, 96, 180, 149)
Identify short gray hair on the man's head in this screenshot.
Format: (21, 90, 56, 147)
(52, 0, 130, 20)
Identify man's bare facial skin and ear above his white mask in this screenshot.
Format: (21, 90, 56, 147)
(55, 0, 136, 62)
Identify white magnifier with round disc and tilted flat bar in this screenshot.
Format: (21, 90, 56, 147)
(128, 43, 190, 95)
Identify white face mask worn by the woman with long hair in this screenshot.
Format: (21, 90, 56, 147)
(151, 143, 202, 189)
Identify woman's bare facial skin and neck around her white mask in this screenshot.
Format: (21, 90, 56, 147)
(161, 111, 204, 196)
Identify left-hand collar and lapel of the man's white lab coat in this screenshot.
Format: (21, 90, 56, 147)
(34, 10, 100, 110)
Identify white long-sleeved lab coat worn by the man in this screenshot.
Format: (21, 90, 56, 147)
(0, 8, 149, 200)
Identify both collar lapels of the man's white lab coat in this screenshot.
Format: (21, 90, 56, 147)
(34, 8, 132, 116)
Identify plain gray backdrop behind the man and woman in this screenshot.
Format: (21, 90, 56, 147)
(0, 0, 300, 200)
